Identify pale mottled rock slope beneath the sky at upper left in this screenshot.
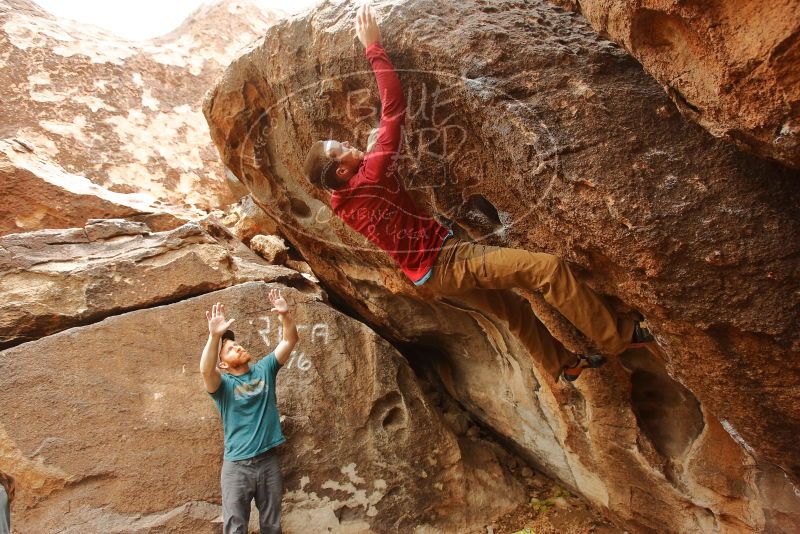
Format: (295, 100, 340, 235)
(0, 0, 276, 214)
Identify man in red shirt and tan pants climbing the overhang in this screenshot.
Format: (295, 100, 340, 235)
(305, 4, 652, 381)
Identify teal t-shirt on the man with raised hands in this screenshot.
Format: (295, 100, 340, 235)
(210, 352, 286, 461)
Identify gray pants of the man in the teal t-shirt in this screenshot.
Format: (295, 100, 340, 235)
(220, 449, 283, 534)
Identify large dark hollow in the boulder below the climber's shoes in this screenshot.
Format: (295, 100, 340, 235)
(620, 349, 704, 459)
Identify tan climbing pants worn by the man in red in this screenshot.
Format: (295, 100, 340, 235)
(425, 237, 633, 380)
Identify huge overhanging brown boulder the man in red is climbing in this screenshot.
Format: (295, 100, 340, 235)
(204, 0, 800, 532)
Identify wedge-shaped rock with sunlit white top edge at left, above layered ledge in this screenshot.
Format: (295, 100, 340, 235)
(0, 141, 194, 235)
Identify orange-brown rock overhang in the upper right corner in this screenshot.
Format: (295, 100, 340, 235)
(556, 0, 800, 168)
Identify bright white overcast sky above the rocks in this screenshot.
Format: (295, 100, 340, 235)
(34, 0, 321, 39)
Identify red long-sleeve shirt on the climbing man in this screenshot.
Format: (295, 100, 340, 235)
(331, 44, 449, 284)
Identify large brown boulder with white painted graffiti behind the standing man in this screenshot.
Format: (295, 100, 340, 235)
(0, 282, 524, 533)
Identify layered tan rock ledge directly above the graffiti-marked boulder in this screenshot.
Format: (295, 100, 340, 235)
(0, 219, 304, 346)
